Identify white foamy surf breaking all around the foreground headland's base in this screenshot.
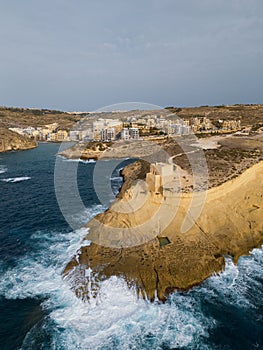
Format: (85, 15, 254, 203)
(0, 213, 263, 350)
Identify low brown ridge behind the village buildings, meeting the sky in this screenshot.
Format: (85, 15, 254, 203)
(0, 104, 263, 128)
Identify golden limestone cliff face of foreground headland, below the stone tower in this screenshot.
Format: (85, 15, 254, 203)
(65, 162, 263, 300)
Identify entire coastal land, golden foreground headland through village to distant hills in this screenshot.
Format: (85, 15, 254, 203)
(0, 105, 263, 300)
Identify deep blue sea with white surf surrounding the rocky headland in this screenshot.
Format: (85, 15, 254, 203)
(0, 144, 263, 350)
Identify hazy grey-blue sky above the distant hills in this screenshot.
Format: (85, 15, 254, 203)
(0, 0, 263, 111)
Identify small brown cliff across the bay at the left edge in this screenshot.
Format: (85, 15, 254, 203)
(0, 128, 37, 152)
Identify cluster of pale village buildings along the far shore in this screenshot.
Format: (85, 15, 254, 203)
(6, 114, 242, 142)
